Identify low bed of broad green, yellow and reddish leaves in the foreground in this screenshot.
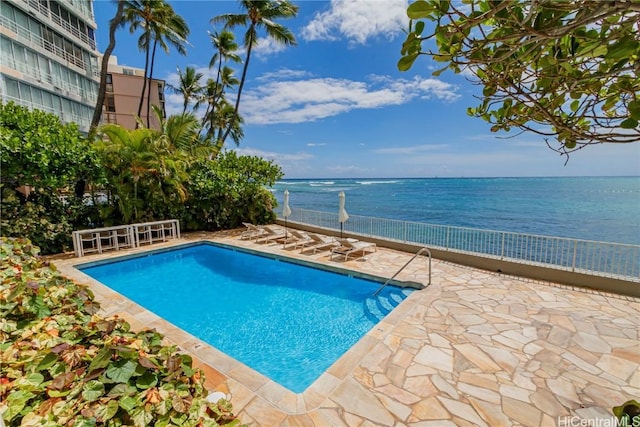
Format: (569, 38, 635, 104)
(0, 237, 239, 427)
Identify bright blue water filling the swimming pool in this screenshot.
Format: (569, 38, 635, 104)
(80, 243, 411, 393)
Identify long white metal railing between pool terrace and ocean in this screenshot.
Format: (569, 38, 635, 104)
(277, 208, 640, 282)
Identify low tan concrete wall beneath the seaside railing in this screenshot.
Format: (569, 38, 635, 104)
(277, 219, 640, 298)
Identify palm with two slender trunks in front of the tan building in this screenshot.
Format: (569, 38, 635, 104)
(124, 0, 189, 124)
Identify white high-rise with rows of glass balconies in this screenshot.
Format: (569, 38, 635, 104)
(0, 0, 100, 132)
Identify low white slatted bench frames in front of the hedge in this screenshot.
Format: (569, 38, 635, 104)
(72, 219, 180, 257)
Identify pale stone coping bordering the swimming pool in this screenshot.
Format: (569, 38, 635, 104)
(53, 237, 428, 415)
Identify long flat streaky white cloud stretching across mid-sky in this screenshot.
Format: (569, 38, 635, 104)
(241, 70, 459, 124)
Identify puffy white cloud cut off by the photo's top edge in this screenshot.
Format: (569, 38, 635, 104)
(302, 0, 409, 44)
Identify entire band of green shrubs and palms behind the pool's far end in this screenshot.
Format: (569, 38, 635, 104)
(0, 104, 282, 253)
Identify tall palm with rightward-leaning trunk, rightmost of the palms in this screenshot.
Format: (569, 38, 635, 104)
(211, 0, 298, 144)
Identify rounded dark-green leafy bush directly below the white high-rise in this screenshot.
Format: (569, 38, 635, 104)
(0, 103, 104, 253)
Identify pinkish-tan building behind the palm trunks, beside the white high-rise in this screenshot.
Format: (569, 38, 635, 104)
(102, 55, 166, 129)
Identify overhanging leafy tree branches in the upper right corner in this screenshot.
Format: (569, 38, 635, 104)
(398, 0, 640, 154)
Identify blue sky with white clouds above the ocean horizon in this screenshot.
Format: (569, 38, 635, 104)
(94, 0, 640, 178)
